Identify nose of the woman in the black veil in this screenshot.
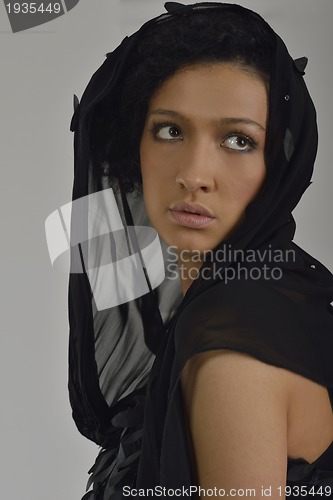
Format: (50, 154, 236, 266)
(176, 141, 216, 192)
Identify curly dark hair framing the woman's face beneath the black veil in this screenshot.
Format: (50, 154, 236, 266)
(92, 4, 274, 191)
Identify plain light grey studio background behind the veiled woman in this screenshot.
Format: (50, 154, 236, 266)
(0, 0, 333, 500)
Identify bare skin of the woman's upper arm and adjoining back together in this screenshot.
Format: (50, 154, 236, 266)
(181, 350, 333, 500)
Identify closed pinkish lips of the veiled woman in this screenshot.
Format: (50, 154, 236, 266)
(170, 203, 215, 229)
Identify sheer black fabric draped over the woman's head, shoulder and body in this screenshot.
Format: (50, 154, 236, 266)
(69, 2, 333, 500)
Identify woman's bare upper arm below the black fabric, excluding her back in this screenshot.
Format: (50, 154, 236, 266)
(181, 350, 289, 499)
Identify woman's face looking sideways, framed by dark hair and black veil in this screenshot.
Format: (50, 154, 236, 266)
(140, 63, 267, 252)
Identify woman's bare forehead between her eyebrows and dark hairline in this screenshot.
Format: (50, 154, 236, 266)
(149, 63, 267, 124)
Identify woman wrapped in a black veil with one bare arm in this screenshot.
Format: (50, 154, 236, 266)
(69, 2, 333, 499)
